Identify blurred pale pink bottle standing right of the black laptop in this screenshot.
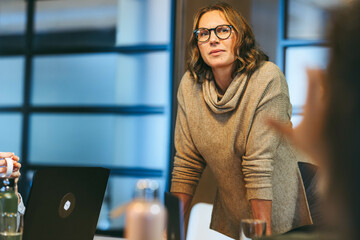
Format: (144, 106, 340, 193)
(125, 179, 166, 240)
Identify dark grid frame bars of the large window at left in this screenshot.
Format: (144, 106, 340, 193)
(0, 0, 176, 235)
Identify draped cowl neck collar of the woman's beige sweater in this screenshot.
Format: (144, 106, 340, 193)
(202, 74, 247, 114)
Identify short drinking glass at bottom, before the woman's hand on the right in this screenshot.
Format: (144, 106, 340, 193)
(240, 219, 266, 240)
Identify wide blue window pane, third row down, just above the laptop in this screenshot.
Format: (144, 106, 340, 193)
(29, 114, 168, 170)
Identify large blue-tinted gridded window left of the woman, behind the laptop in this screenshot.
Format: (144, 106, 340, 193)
(0, 0, 175, 234)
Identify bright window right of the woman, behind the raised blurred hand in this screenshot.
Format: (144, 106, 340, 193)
(277, 0, 337, 126)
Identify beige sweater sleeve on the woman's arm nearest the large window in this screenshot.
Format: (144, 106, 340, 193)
(171, 79, 206, 195)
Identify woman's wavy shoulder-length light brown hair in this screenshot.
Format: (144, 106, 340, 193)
(186, 3, 269, 81)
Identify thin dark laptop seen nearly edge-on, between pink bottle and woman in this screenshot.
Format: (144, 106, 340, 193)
(165, 192, 185, 240)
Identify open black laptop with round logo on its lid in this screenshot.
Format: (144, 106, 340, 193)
(23, 167, 110, 240)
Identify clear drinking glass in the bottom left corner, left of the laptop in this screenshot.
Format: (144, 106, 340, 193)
(0, 212, 24, 240)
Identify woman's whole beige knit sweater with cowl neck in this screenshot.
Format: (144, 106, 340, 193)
(171, 62, 311, 238)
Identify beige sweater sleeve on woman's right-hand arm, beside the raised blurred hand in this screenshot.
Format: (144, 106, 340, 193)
(242, 71, 292, 200)
